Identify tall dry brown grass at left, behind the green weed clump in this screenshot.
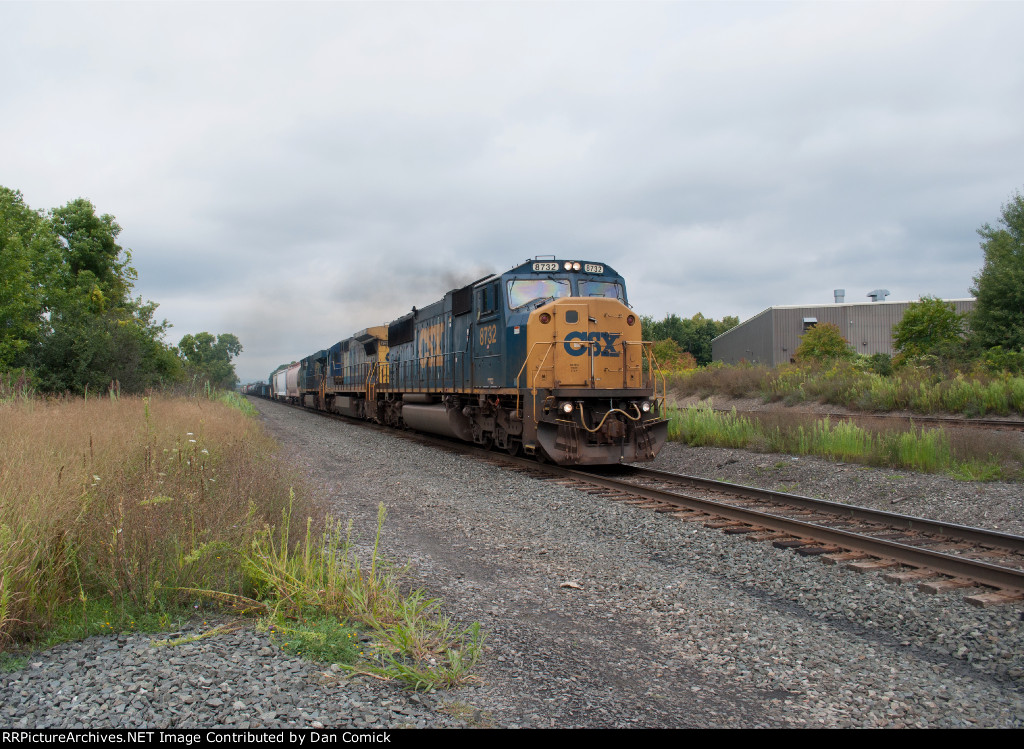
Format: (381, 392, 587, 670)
(0, 397, 305, 648)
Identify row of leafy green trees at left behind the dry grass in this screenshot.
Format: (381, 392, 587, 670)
(0, 186, 242, 393)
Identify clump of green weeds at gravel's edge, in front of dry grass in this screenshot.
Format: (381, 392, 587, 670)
(237, 504, 483, 689)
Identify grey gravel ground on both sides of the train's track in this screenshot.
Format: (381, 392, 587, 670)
(0, 402, 1024, 727)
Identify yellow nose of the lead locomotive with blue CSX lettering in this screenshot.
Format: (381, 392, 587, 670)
(520, 297, 643, 390)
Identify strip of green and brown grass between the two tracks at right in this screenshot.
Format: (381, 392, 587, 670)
(669, 405, 1024, 481)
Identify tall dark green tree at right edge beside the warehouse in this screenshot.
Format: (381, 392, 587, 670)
(971, 187, 1024, 351)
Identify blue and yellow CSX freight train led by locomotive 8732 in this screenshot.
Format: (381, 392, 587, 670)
(266, 258, 668, 464)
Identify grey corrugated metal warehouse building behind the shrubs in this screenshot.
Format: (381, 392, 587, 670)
(711, 301, 974, 367)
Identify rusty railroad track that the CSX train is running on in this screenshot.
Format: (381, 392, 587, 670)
(253, 397, 1024, 606)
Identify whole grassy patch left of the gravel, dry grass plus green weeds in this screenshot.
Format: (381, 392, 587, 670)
(0, 393, 483, 689)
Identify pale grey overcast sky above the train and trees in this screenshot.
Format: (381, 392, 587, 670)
(0, 2, 1024, 381)
